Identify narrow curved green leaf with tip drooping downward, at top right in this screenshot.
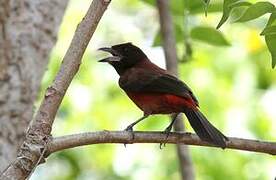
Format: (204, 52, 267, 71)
(216, 0, 251, 29)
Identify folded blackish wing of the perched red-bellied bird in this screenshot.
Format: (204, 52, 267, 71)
(120, 71, 198, 105)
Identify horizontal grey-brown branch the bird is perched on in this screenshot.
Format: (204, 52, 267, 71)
(46, 130, 276, 155)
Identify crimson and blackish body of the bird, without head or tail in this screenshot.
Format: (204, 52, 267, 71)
(119, 58, 198, 114)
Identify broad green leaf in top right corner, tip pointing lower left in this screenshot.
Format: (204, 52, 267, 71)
(235, 2, 276, 22)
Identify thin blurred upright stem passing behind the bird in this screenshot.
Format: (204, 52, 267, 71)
(157, 0, 195, 180)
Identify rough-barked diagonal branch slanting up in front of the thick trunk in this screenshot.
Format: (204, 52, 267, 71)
(0, 0, 111, 180)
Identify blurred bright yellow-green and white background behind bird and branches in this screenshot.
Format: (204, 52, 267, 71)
(31, 0, 276, 180)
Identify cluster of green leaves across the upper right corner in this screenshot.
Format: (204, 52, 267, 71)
(144, 0, 276, 68)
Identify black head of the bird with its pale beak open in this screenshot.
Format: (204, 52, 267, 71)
(99, 43, 147, 75)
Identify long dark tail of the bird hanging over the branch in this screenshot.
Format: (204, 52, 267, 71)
(184, 109, 228, 149)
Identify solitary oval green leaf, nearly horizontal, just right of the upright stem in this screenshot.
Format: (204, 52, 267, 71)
(191, 26, 230, 46)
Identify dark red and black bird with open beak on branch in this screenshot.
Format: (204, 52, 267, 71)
(99, 42, 228, 149)
